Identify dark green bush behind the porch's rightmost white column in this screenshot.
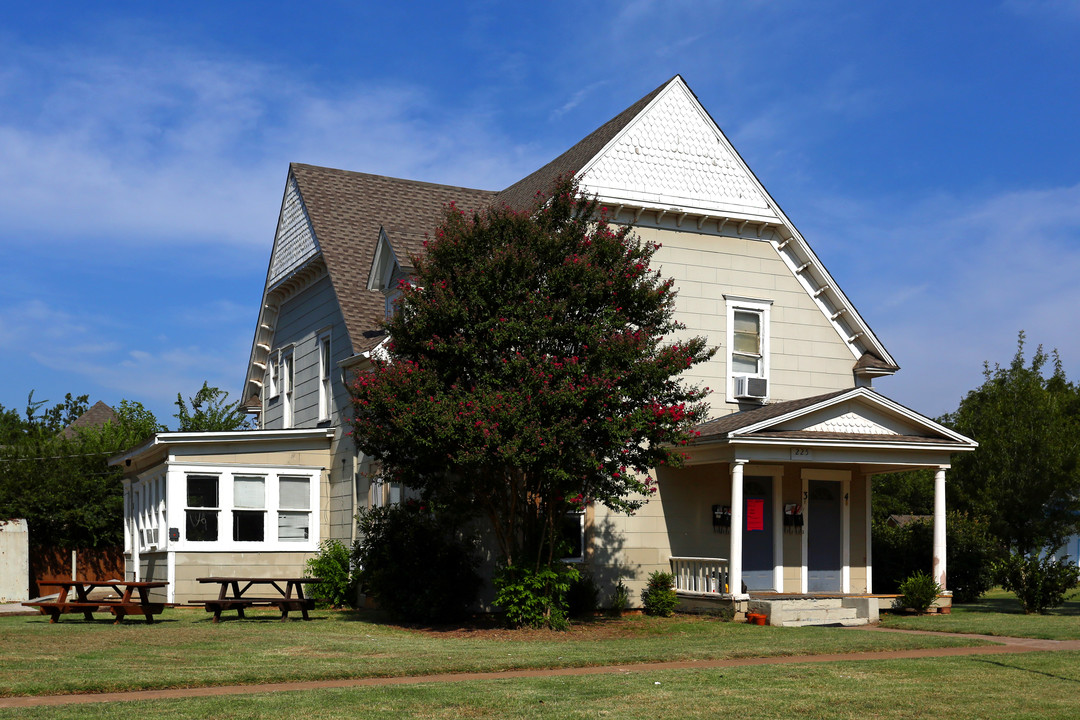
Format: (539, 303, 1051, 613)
(873, 513, 1000, 603)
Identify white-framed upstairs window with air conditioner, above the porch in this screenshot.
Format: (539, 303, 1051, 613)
(724, 295, 772, 403)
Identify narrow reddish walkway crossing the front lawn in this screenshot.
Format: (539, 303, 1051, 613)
(0, 627, 1080, 708)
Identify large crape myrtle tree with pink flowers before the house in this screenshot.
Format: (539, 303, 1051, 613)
(351, 178, 715, 571)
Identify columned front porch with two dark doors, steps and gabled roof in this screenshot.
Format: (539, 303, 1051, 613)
(657, 388, 975, 625)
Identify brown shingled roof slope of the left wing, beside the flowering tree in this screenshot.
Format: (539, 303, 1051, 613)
(289, 163, 496, 353)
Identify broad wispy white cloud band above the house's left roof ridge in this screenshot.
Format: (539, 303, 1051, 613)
(0, 38, 535, 247)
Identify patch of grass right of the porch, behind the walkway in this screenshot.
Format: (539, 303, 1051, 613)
(881, 588, 1080, 639)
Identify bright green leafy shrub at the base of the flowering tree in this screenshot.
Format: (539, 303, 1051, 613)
(495, 562, 579, 630)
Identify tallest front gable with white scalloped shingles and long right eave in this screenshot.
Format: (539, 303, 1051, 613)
(498, 76, 900, 375)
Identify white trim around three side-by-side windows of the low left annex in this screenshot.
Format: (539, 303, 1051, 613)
(167, 463, 322, 553)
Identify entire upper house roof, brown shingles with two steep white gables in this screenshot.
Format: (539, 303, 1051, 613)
(244, 76, 899, 404)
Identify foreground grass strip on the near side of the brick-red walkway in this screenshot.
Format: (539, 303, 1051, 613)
(0, 651, 1080, 720)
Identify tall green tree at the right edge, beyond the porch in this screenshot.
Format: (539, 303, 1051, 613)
(945, 332, 1080, 555)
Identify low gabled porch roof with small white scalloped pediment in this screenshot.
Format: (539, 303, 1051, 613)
(693, 388, 978, 450)
